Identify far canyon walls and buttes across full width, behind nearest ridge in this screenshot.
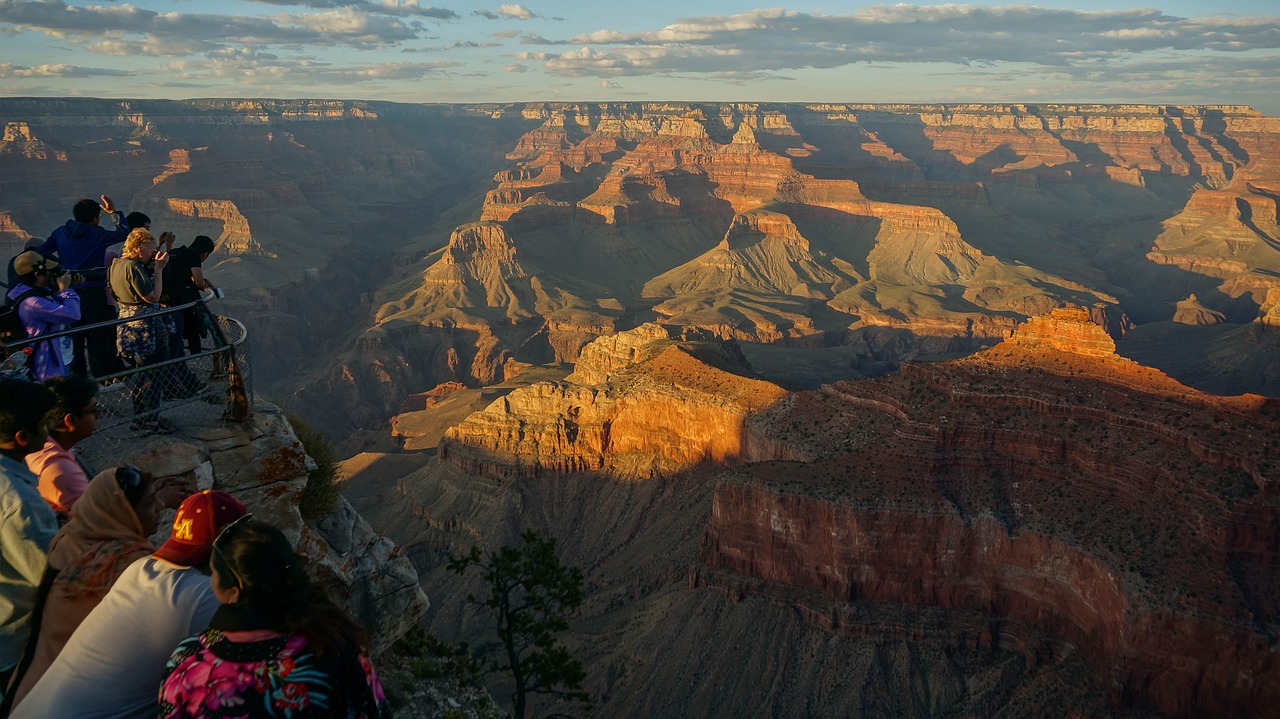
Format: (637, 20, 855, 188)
(0, 99, 1280, 430)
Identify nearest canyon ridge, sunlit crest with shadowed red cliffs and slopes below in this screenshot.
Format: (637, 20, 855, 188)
(349, 310, 1280, 716)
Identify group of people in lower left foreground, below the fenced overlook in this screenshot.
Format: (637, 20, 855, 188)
(0, 376, 389, 719)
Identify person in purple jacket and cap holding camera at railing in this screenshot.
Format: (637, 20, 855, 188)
(8, 249, 81, 383)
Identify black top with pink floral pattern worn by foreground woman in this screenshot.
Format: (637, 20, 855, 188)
(159, 629, 390, 719)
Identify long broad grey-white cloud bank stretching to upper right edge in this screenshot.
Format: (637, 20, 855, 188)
(522, 4, 1280, 77)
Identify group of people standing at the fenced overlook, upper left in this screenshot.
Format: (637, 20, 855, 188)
(5, 194, 216, 434)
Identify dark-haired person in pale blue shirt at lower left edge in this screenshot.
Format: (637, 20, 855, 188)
(0, 379, 58, 691)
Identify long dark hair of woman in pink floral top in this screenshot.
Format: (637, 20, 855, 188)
(210, 519, 366, 654)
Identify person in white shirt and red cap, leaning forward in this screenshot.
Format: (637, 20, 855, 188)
(10, 490, 248, 719)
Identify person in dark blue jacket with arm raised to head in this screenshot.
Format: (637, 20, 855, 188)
(36, 194, 129, 377)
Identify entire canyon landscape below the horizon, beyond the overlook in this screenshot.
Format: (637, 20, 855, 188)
(0, 99, 1280, 716)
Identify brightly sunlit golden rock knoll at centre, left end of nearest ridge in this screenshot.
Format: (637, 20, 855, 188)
(439, 325, 788, 478)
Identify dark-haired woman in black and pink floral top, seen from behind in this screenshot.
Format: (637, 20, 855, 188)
(160, 519, 390, 719)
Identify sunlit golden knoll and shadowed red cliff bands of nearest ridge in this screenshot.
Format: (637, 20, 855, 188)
(433, 308, 1280, 716)
